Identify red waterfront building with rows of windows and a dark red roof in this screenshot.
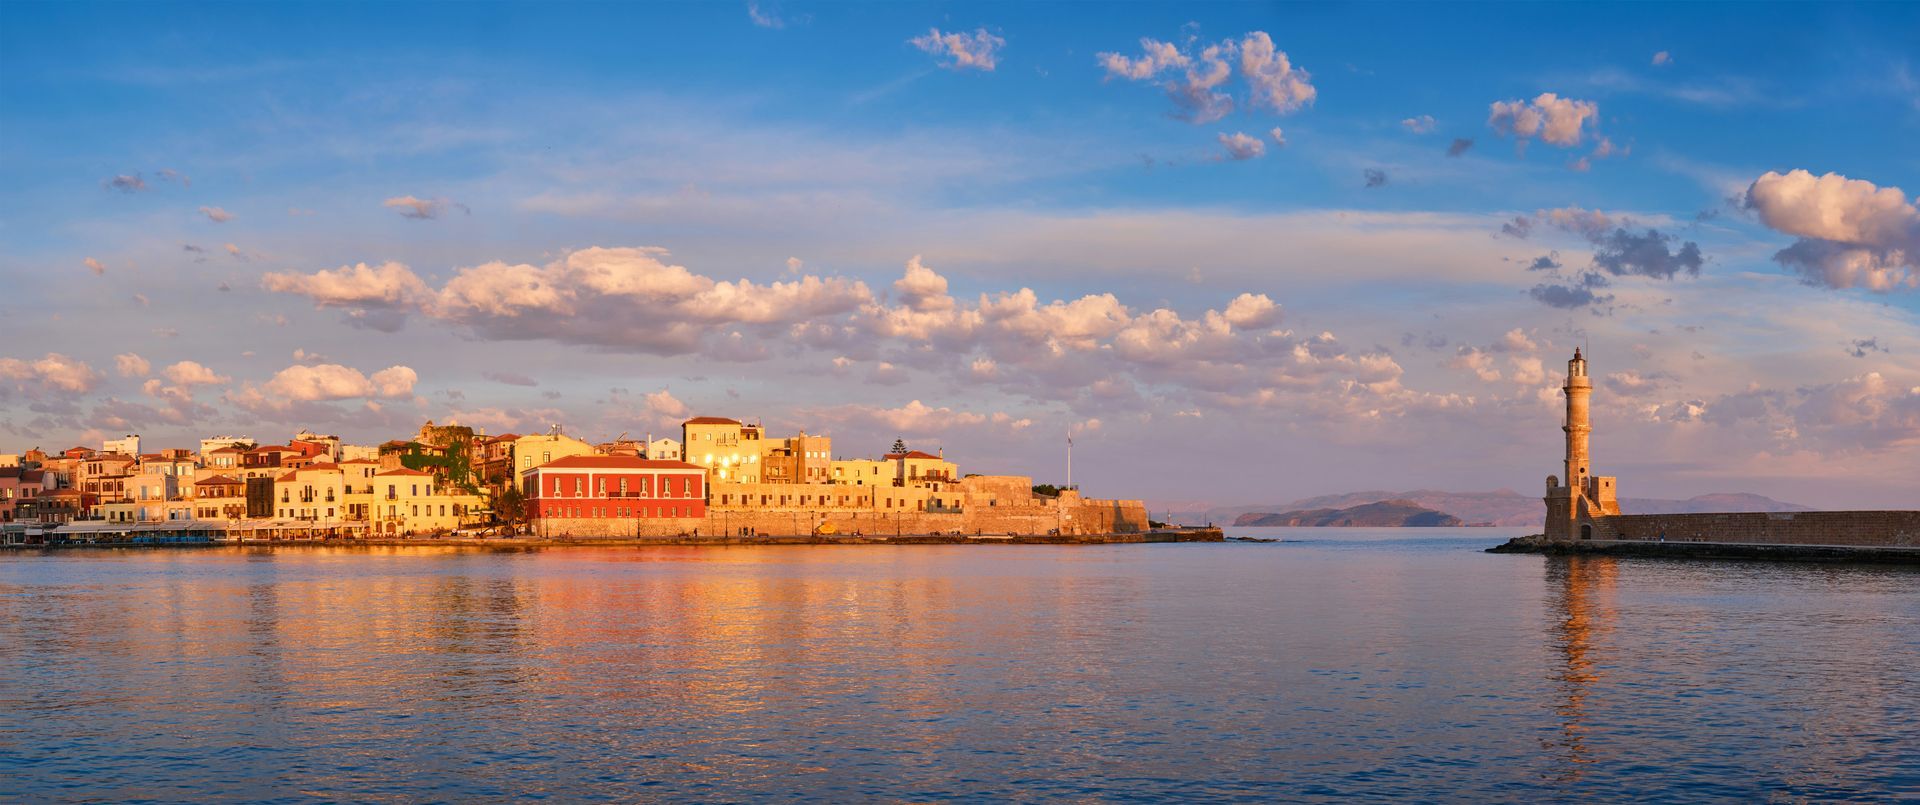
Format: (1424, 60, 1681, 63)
(520, 455, 707, 521)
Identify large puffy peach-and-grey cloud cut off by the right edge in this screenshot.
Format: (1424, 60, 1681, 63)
(1743, 169, 1920, 292)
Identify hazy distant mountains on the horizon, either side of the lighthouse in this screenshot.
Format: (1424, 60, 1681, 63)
(1173, 490, 1812, 526)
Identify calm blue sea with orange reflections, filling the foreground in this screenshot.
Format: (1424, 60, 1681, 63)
(0, 528, 1920, 801)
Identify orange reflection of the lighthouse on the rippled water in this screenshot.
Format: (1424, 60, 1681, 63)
(1546, 557, 1619, 782)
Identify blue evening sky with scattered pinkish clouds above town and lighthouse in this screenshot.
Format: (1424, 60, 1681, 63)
(0, 2, 1920, 509)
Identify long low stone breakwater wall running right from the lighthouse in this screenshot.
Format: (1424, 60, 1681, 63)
(1594, 511, 1920, 548)
